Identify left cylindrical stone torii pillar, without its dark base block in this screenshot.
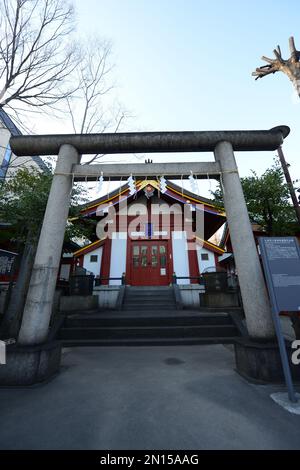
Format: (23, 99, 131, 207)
(18, 144, 79, 346)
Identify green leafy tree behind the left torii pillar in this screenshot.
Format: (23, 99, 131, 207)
(0, 168, 92, 337)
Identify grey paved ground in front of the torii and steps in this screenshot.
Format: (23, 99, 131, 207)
(0, 346, 300, 450)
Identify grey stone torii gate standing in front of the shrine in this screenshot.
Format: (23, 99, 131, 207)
(0, 126, 290, 385)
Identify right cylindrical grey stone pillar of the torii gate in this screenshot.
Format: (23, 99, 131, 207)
(214, 142, 275, 341)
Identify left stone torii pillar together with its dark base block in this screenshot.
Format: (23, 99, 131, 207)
(0, 144, 80, 385)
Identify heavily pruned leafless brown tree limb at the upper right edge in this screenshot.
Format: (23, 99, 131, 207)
(252, 37, 300, 97)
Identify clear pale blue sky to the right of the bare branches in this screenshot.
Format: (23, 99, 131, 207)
(39, 0, 300, 195)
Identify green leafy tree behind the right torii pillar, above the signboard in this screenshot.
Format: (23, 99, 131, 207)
(212, 160, 299, 236)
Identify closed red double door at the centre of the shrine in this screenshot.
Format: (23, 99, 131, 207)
(130, 240, 170, 286)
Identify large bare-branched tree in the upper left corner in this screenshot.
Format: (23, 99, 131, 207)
(0, 0, 79, 122)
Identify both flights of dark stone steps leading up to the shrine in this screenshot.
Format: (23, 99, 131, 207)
(56, 287, 244, 347)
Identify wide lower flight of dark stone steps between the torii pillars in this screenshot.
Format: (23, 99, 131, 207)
(57, 311, 241, 347)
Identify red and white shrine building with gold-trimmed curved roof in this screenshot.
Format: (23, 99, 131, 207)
(67, 180, 226, 286)
